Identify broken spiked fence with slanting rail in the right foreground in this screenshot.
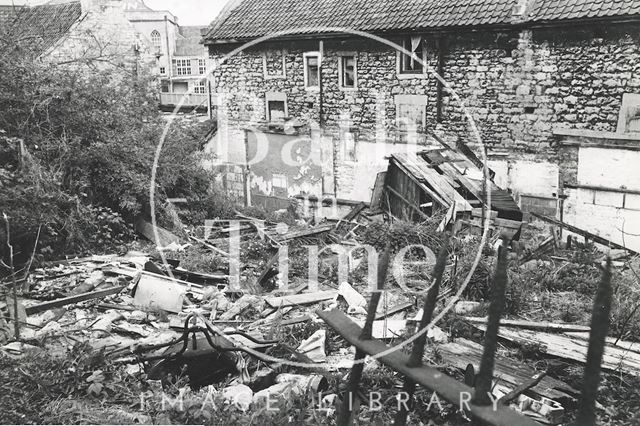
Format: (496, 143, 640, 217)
(318, 235, 612, 426)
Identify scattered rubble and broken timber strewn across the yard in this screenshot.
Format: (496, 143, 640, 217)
(0, 205, 640, 424)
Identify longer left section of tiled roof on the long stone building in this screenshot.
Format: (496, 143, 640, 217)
(205, 0, 518, 42)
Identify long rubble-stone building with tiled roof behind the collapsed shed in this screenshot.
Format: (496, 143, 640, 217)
(204, 0, 640, 251)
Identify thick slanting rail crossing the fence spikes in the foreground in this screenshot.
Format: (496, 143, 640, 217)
(317, 309, 538, 426)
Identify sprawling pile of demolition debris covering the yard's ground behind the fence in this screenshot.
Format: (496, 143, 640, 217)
(0, 204, 640, 424)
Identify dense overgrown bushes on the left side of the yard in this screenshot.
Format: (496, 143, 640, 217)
(0, 33, 233, 263)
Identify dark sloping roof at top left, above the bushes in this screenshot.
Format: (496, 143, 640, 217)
(11, 1, 82, 55)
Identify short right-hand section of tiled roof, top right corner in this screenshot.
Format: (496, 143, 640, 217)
(528, 0, 640, 22)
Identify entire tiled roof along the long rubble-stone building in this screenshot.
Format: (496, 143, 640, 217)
(205, 0, 640, 42)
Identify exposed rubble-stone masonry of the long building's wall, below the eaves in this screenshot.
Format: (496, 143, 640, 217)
(210, 24, 640, 205)
